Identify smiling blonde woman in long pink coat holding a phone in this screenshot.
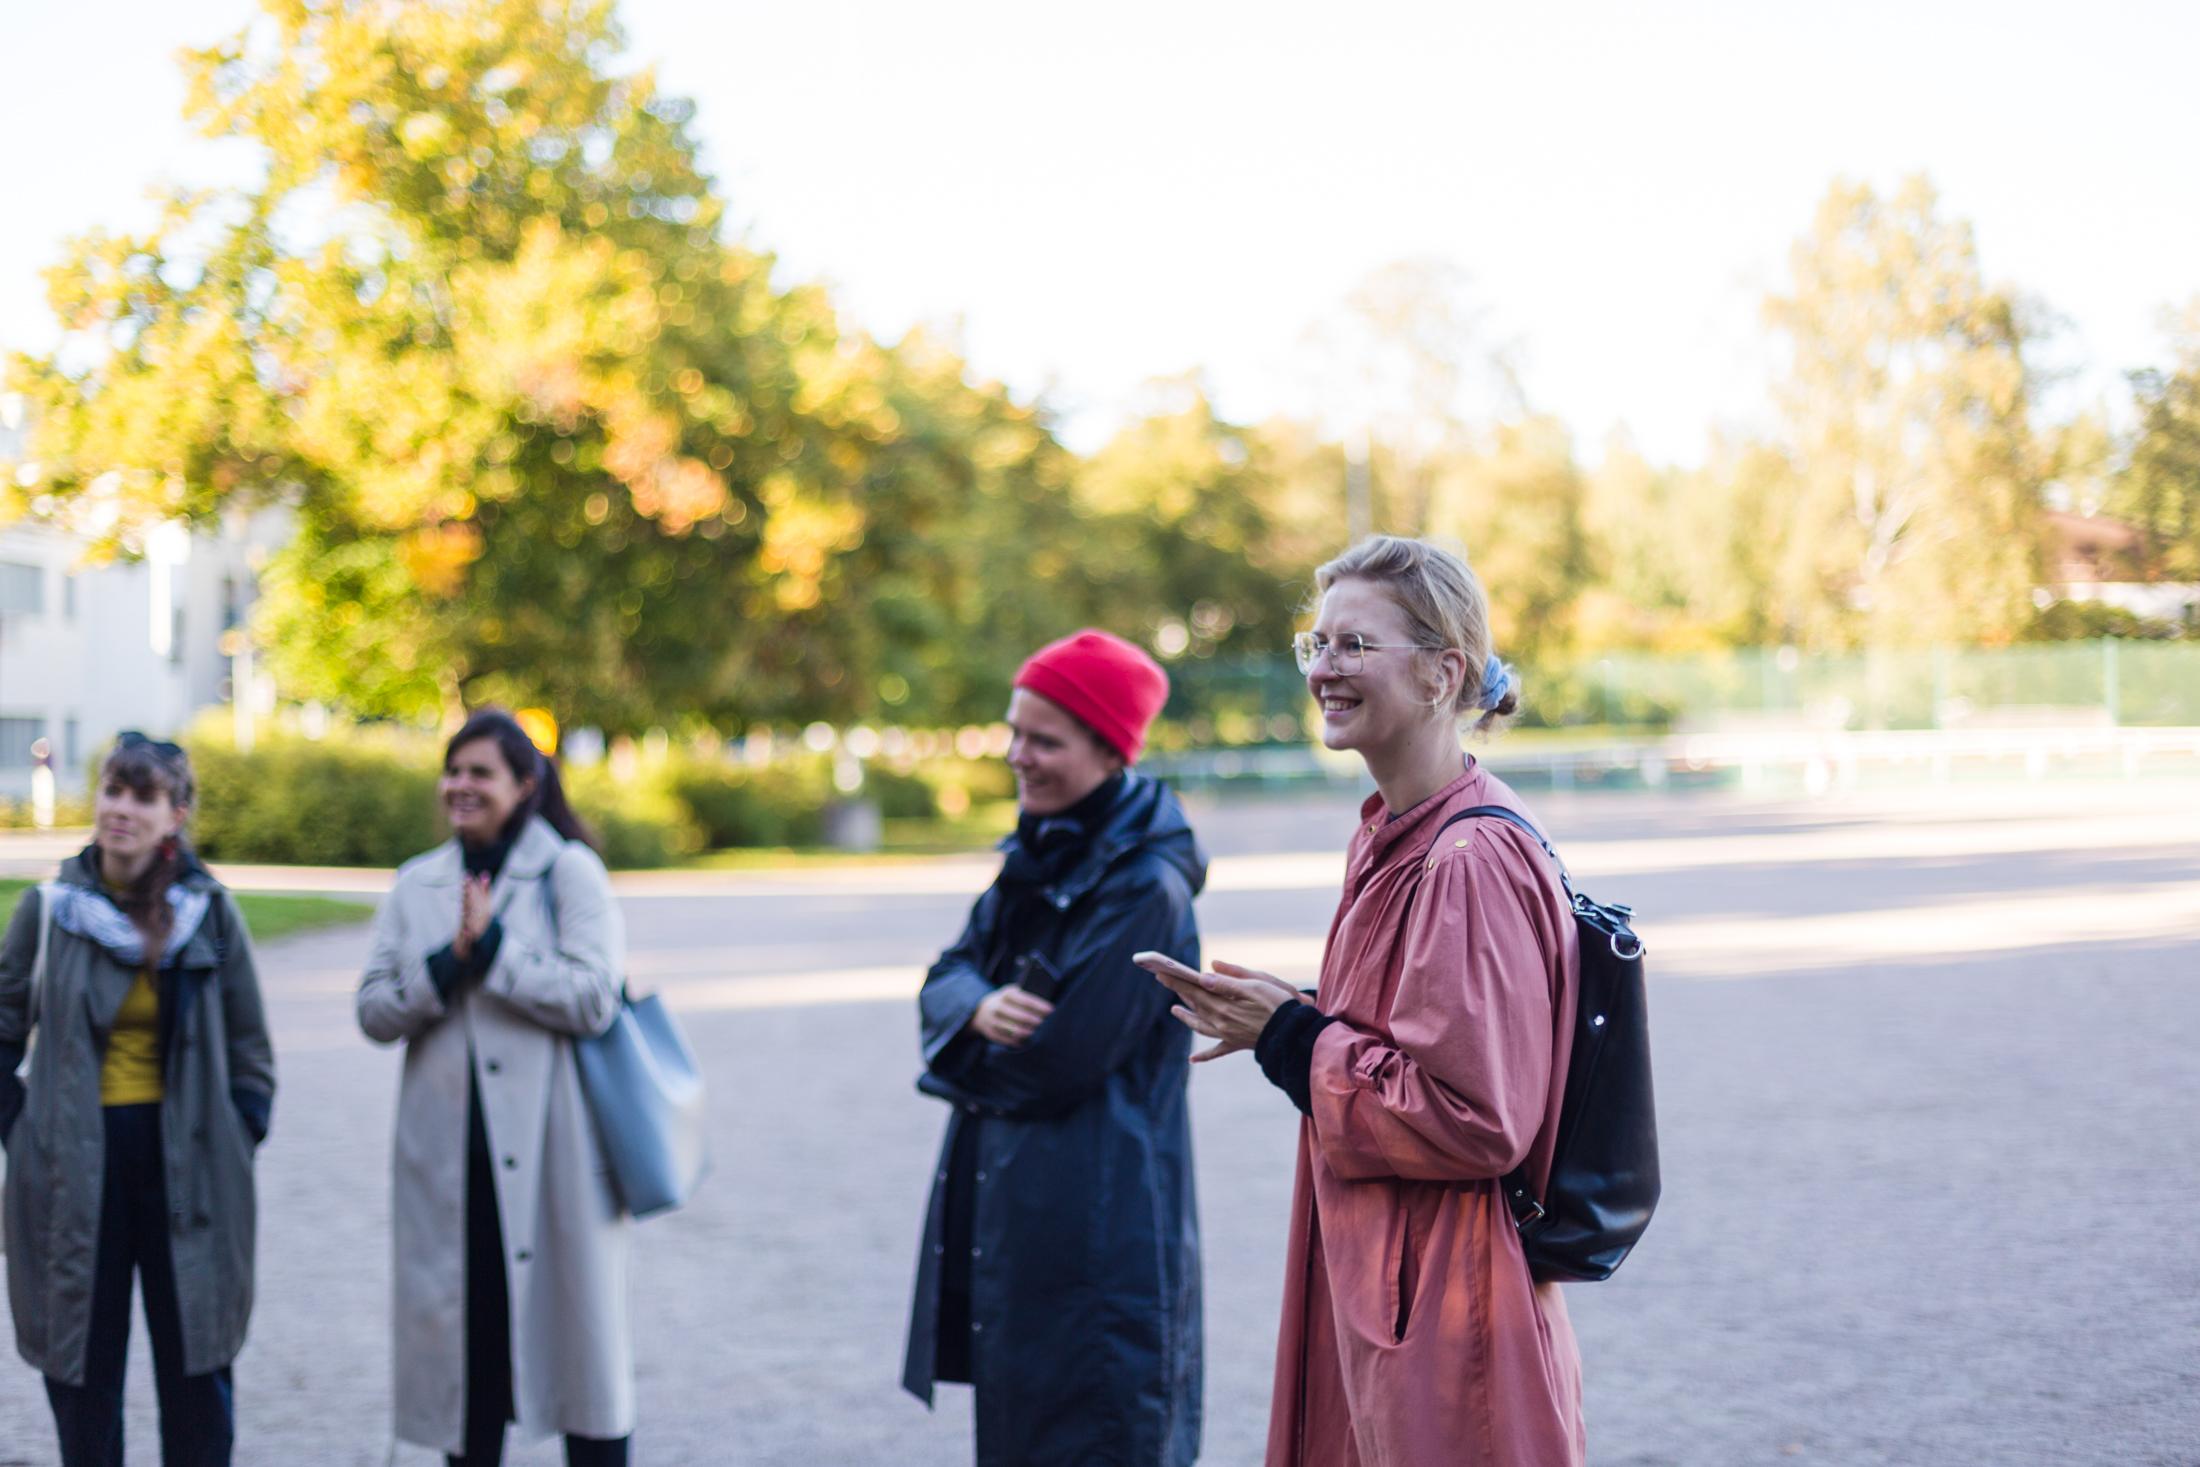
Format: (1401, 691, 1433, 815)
(1153, 537, 1584, 1467)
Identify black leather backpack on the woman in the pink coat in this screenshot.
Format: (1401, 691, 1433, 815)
(1430, 805, 1659, 1282)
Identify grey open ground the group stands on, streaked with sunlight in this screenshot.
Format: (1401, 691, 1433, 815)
(0, 785, 2200, 1467)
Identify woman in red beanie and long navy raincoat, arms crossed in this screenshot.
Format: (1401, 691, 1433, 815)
(902, 631, 1208, 1467)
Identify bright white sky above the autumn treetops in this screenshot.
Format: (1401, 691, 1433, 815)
(0, 0, 2200, 462)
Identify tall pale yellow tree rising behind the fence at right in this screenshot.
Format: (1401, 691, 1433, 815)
(1767, 178, 2042, 644)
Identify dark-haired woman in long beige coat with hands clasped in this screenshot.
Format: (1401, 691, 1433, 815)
(359, 710, 634, 1467)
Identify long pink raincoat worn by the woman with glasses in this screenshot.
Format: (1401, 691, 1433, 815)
(1267, 763, 1584, 1467)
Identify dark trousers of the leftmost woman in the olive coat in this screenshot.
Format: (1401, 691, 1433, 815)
(46, 1104, 235, 1467)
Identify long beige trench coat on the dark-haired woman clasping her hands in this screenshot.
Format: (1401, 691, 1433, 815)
(359, 818, 634, 1452)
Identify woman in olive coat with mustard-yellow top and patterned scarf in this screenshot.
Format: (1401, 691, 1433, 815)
(0, 735, 275, 1467)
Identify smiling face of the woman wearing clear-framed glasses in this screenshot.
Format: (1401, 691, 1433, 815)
(1307, 578, 1465, 761)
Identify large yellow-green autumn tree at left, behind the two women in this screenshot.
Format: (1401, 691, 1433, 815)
(13, 0, 1091, 728)
